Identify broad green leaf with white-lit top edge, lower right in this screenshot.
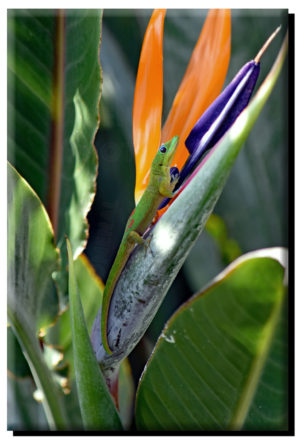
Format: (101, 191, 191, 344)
(136, 249, 287, 430)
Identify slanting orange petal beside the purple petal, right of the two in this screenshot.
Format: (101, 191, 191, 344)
(161, 9, 231, 170)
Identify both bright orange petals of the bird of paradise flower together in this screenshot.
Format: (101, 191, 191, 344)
(133, 9, 231, 203)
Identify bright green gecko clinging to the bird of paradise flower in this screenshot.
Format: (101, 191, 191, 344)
(101, 136, 178, 354)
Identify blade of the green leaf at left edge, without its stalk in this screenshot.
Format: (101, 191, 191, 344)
(7, 164, 59, 335)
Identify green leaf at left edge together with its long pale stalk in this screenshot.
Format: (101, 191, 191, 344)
(7, 165, 67, 429)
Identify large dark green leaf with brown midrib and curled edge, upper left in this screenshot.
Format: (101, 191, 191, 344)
(8, 9, 101, 276)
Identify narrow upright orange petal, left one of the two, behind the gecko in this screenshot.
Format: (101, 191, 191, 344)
(133, 9, 166, 202)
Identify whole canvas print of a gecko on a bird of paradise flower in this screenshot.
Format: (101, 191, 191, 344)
(7, 9, 293, 435)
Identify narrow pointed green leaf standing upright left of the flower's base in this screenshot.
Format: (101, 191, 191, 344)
(67, 239, 122, 430)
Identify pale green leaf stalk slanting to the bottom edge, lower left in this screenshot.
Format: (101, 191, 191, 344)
(7, 307, 68, 430)
